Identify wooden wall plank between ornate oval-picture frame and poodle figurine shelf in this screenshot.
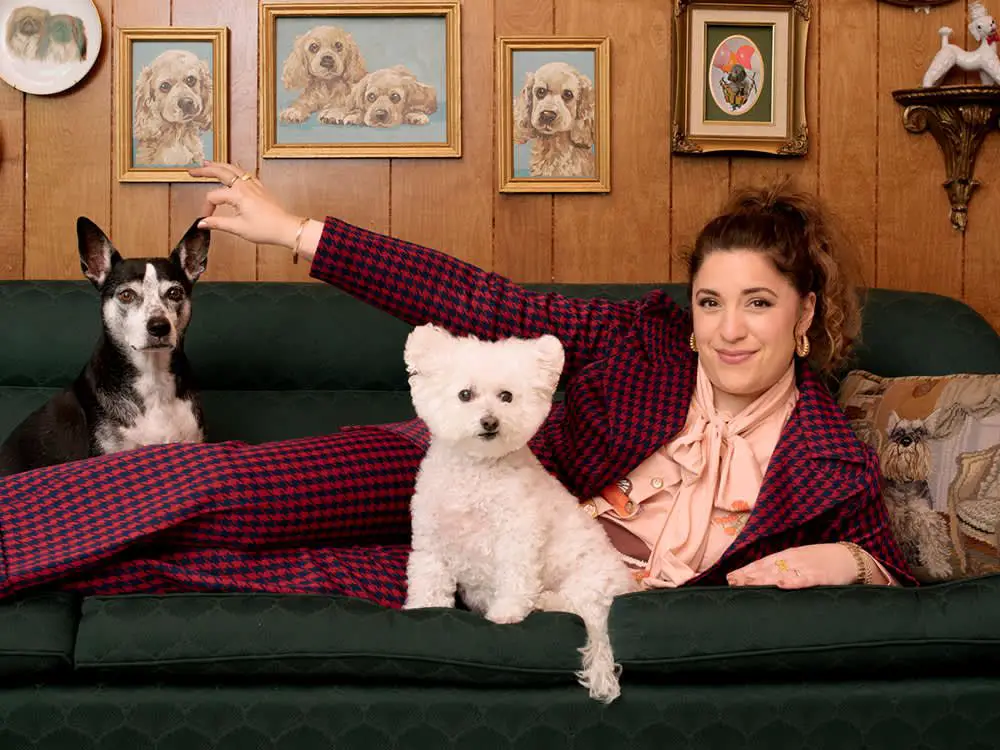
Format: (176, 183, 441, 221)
(819, 0, 878, 284)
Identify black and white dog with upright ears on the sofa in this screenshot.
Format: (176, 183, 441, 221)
(0, 217, 209, 475)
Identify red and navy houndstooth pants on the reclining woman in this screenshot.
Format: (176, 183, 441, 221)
(0, 427, 425, 607)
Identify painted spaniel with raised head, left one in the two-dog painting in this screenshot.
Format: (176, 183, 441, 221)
(278, 26, 368, 125)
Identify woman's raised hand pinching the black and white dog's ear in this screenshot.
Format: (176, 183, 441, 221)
(188, 161, 302, 249)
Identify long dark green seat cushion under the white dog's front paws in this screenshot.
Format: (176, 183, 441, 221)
(76, 594, 585, 684)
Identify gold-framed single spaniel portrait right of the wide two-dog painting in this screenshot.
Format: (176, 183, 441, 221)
(496, 37, 611, 193)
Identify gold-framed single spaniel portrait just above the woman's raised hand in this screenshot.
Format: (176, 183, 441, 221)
(115, 27, 229, 182)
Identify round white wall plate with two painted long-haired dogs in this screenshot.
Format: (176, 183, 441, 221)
(0, 0, 101, 94)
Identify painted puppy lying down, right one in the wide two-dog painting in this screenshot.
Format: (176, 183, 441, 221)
(344, 65, 437, 128)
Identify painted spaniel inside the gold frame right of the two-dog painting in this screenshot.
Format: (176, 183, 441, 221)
(514, 62, 594, 177)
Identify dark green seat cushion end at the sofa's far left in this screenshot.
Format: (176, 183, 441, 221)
(0, 593, 79, 677)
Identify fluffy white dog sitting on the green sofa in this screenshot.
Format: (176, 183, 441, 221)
(404, 325, 635, 703)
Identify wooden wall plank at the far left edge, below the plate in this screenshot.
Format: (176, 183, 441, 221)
(0, 81, 25, 279)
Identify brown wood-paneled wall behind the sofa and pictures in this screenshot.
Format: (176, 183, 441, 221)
(0, 0, 1000, 328)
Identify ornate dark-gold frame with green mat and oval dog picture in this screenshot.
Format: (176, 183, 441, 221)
(672, 0, 810, 156)
